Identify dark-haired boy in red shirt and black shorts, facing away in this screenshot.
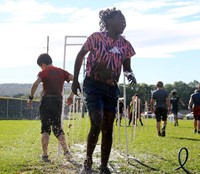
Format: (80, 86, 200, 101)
(27, 54, 73, 162)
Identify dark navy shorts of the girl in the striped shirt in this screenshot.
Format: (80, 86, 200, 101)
(83, 77, 119, 113)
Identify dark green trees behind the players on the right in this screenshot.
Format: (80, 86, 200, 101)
(119, 80, 199, 110)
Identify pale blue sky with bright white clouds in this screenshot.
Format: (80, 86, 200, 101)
(0, 0, 200, 84)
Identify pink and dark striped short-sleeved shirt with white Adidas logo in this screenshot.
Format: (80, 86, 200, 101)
(84, 32, 135, 84)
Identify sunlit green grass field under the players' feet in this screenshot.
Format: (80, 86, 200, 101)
(0, 115, 200, 174)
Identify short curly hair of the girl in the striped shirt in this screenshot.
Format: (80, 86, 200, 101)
(99, 7, 122, 31)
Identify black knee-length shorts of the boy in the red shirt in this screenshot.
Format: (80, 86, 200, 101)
(40, 96, 64, 137)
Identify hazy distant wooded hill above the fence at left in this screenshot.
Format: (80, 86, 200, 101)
(0, 83, 71, 97)
